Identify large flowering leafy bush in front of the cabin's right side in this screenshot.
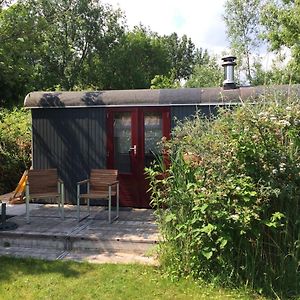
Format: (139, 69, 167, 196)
(146, 96, 300, 296)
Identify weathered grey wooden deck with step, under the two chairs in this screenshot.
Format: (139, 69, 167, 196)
(0, 204, 159, 264)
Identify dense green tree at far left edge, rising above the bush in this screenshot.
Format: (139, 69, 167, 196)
(0, 1, 45, 106)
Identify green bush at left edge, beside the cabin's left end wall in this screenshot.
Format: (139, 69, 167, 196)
(0, 108, 31, 194)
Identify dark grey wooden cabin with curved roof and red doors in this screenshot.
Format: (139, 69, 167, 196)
(25, 86, 300, 207)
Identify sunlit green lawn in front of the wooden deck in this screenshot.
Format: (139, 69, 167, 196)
(0, 257, 262, 300)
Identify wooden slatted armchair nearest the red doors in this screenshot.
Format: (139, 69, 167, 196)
(77, 169, 119, 223)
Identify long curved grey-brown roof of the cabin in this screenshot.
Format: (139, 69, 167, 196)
(24, 85, 300, 108)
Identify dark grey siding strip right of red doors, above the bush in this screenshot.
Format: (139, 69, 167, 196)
(171, 105, 217, 128)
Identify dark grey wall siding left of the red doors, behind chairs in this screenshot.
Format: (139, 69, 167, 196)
(32, 108, 106, 203)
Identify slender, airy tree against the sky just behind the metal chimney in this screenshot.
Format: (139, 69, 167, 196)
(224, 0, 261, 83)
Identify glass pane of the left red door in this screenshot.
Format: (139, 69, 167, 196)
(113, 112, 132, 173)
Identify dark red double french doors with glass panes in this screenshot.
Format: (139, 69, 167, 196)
(107, 107, 171, 207)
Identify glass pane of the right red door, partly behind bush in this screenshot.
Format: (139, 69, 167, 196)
(144, 112, 162, 167)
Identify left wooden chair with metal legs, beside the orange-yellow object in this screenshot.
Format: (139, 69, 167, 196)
(25, 169, 65, 223)
